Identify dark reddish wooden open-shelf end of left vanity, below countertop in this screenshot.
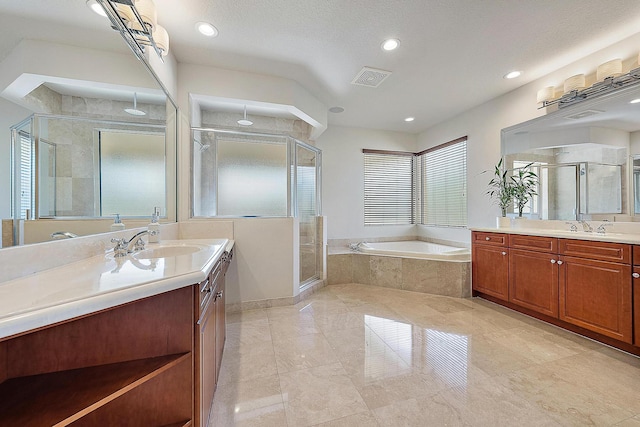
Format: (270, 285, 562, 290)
(0, 286, 194, 427)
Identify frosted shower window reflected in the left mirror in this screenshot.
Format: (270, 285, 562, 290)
(100, 131, 166, 216)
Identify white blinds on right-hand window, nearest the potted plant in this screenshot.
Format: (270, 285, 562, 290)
(420, 137, 467, 227)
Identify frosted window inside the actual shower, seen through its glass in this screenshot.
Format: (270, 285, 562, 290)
(217, 139, 288, 216)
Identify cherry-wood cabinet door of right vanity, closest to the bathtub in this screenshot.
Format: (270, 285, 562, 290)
(471, 245, 509, 301)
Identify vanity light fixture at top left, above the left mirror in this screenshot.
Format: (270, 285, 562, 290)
(92, 0, 169, 62)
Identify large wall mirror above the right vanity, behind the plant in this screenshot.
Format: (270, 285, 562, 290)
(501, 86, 640, 221)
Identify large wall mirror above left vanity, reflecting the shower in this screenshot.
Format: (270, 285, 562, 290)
(0, 0, 177, 247)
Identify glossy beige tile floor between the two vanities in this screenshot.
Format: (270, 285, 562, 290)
(213, 284, 640, 427)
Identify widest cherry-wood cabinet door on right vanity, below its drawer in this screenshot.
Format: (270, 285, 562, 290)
(559, 257, 633, 344)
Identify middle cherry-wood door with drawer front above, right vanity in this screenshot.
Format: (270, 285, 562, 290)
(509, 234, 558, 318)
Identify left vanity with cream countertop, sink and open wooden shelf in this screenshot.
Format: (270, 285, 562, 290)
(0, 239, 233, 426)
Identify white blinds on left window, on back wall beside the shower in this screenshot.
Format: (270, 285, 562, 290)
(363, 150, 414, 225)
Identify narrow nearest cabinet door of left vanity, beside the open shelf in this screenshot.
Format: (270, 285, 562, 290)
(196, 297, 216, 427)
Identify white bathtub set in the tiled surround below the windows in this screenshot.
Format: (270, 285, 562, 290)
(356, 240, 471, 262)
